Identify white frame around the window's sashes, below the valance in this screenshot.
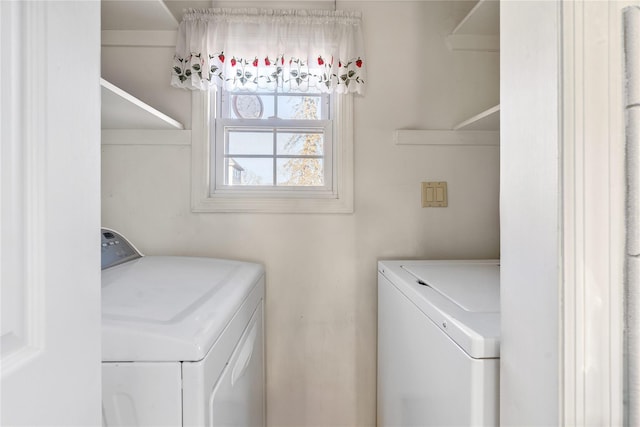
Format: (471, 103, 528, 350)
(191, 91, 353, 213)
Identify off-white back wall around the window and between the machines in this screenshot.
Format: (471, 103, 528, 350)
(102, 1, 500, 426)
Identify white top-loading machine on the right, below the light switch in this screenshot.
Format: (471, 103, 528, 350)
(378, 260, 500, 427)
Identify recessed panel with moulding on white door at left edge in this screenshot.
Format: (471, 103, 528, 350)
(0, 2, 47, 376)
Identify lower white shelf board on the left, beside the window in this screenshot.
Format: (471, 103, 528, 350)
(100, 79, 184, 130)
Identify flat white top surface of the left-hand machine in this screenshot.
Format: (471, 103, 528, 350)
(102, 256, 264, 361)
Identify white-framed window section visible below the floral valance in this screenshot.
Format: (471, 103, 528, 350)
(192, 88, 353, 213)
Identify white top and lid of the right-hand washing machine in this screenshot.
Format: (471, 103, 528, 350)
(379, 260, 500, 359)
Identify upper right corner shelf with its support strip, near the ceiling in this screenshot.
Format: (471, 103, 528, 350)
(447, 0, 500, 52)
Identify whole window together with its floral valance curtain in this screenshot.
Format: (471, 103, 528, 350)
(176, 8, 366, 213)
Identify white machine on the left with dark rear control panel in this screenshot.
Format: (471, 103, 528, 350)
(101, 229, 265, 427)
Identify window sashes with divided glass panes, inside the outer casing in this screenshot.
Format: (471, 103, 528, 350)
(211, 90, 333, 194)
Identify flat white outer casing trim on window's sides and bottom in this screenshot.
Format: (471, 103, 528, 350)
(191, 91, 354, 213)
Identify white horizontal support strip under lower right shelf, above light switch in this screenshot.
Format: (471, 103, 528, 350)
(393, 129, 500, 145)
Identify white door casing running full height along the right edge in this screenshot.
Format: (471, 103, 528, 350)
(560, 0, 625, 425)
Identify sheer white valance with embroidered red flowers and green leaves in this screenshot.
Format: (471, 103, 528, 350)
(171, 9, 366, 94)
